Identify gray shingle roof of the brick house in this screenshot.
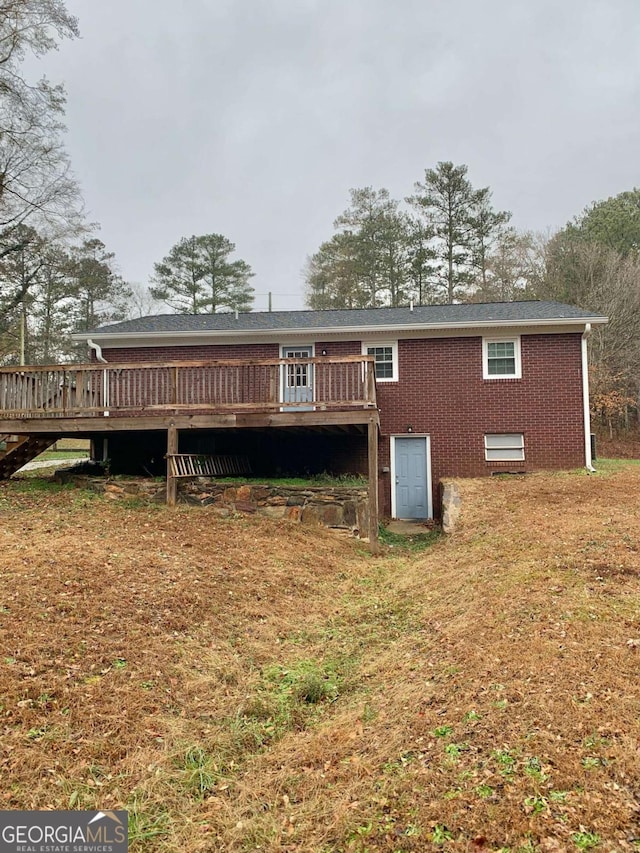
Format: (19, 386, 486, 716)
(89, 301, 603, 337)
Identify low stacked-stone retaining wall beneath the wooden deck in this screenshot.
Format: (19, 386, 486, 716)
(56, 472, 369, 537)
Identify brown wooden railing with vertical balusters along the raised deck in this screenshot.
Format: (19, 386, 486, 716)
(0, 356, 376, 420)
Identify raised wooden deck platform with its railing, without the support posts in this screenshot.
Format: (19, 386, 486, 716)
(0, 356, 377, 434)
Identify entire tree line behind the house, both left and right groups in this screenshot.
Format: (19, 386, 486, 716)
(0, 0, 640, 428)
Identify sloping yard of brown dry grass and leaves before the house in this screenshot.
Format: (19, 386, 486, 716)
(0, 463, 640, 853)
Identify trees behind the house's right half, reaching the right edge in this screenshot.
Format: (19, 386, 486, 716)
(304, 168, 640, 431)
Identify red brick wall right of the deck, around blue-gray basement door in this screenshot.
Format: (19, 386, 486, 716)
(378, 334, 584, 514)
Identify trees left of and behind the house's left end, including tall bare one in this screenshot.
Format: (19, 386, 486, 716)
(0, 0, 253, 364)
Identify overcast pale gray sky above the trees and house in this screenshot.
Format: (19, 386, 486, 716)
(40, 0, 640, 310)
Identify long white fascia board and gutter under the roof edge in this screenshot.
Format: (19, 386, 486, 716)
(72, 317, 608, 348)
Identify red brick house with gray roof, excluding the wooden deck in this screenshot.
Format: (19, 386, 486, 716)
(81, 301, 606, 518)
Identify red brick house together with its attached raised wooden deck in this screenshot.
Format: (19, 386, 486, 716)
(0, 301, 606, 518)
